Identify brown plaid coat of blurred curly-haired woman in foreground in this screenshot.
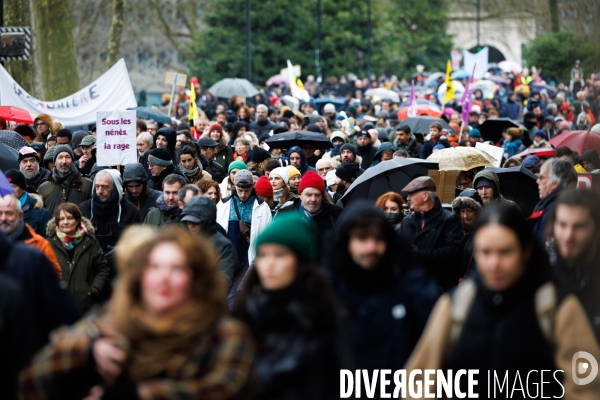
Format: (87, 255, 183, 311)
(19, 317, 254, 400)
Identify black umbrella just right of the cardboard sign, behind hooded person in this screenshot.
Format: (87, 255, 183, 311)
(486, 166, 540, 217)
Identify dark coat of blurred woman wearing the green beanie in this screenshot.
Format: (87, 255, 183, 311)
(234, 269, 354, 400)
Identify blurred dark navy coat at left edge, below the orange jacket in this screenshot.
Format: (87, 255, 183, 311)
(0, 231, 81, 360)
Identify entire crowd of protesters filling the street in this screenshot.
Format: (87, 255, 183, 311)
(0, 60, 600, 399)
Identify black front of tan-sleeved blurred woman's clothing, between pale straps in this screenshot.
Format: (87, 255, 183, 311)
(442, 246, 571, 398)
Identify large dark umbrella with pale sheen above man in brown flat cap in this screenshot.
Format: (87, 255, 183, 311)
(342, 158, 438, 206)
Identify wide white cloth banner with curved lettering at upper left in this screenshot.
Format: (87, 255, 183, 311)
(0, 59, 137, 125)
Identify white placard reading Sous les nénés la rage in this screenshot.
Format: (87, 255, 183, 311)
(96, 110, 137, 167)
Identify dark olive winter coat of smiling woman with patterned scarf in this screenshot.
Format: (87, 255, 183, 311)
(47, 218, 110, 313)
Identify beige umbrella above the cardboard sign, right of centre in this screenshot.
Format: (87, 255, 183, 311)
(427, 147, 496, 171)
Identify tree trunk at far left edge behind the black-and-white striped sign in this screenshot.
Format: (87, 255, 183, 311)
(4, 0, 35, 93)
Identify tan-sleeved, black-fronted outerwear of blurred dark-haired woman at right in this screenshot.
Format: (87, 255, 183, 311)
(406, 246, 600, 400)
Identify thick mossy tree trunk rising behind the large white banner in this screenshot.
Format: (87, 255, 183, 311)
(33, 0, 79, 101)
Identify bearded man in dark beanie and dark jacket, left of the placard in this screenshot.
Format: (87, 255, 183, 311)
(38, 145, 93, 214)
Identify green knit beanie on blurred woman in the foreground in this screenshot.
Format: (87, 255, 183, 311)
(256, 211, 317, 263)
